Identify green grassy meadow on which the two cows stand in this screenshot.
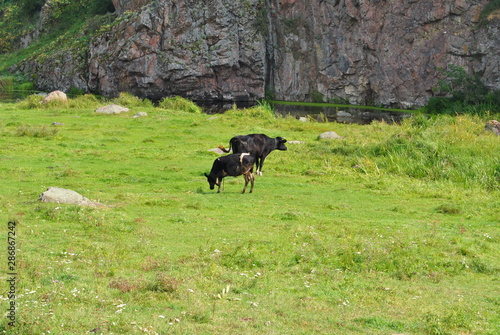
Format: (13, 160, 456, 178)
(0, 96, 500, 334)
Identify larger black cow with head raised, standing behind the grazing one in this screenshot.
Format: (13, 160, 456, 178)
(219, 134, 287, 176)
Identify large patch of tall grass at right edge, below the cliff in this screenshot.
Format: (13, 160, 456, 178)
(331, 115, 500, 190)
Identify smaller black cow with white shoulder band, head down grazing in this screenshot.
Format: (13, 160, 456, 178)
(205, 153, 255, 193)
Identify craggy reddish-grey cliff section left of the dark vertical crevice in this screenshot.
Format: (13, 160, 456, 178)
(89, 0, 266, 101)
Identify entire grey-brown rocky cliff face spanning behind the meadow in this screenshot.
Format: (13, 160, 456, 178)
(13, 0, 500, 107)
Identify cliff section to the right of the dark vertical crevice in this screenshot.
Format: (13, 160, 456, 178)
(271, 0, 500, 107)
